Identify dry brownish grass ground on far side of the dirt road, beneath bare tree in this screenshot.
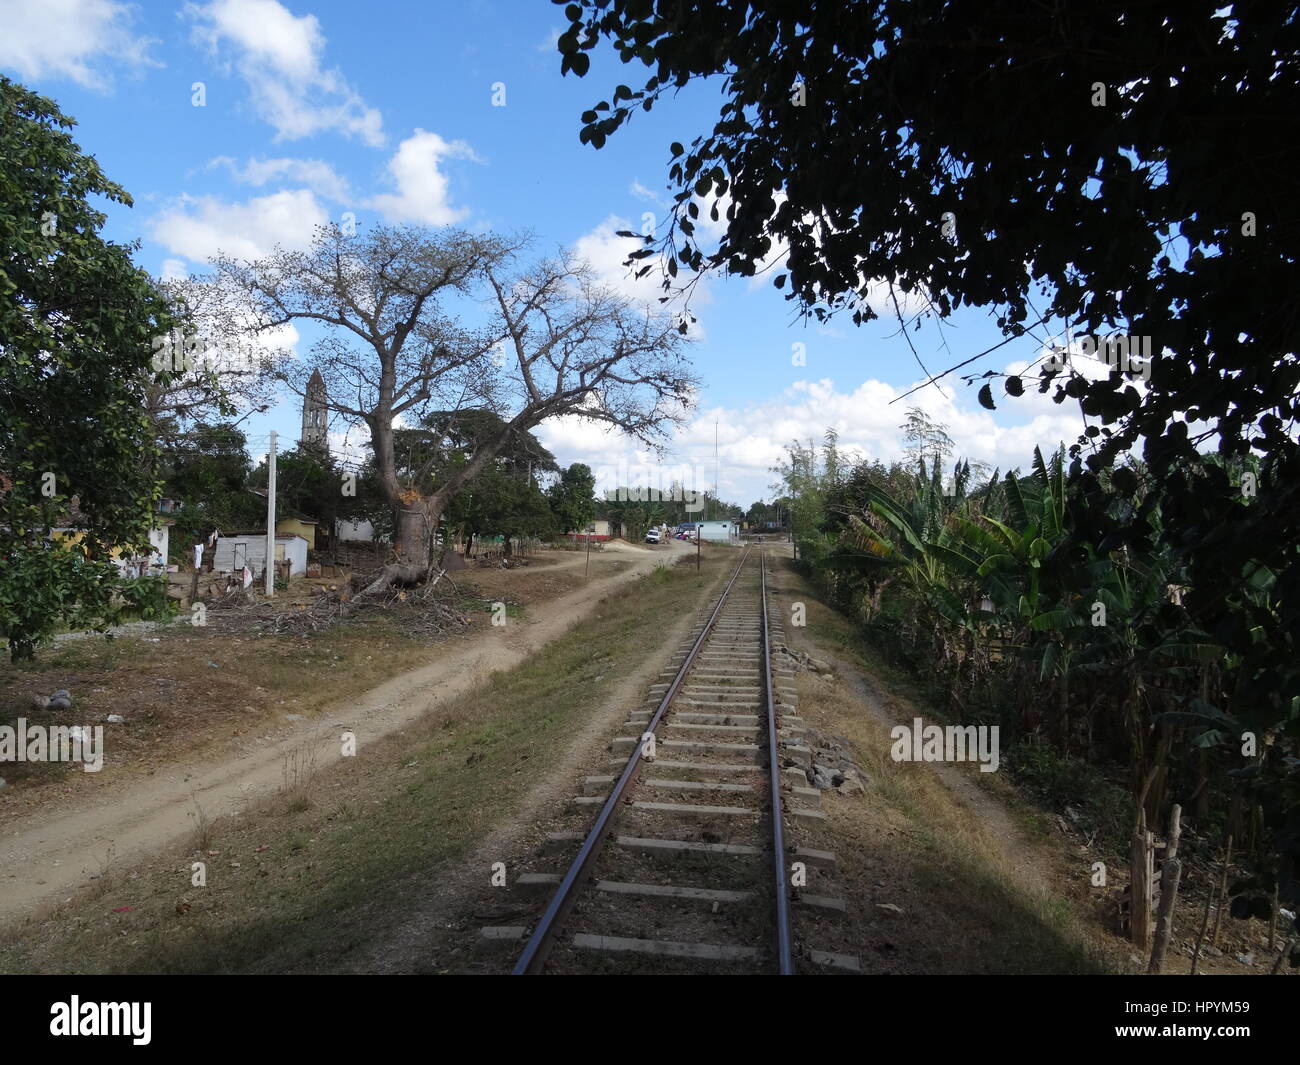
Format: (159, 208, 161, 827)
(0, 553, 627, 817)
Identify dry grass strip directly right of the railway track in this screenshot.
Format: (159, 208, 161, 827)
(777, 570, 1114, 973)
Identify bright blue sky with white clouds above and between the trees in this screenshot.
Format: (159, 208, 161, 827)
(0, 0, 1097, 503)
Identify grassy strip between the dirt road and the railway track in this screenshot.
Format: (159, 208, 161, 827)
(0, 553, 728, 973)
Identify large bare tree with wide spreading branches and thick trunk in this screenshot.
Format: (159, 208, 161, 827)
(213, 226, 694, 576)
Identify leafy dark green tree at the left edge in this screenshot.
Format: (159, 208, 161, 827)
(0, 78, 174, 659)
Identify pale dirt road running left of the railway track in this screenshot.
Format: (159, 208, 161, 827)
(0, 545, 685, 921)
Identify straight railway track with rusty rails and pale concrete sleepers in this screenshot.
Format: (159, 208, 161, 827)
(482, 547, 857, 975)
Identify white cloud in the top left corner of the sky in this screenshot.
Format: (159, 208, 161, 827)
(0, 0, 159, 88)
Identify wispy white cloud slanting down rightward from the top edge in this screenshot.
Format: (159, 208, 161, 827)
(185, 0, 384, 146)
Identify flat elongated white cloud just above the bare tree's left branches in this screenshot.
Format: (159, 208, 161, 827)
(151, 189, 329, 263)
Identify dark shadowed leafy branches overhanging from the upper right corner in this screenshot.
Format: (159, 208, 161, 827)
(558, 0, 1300, 889)
